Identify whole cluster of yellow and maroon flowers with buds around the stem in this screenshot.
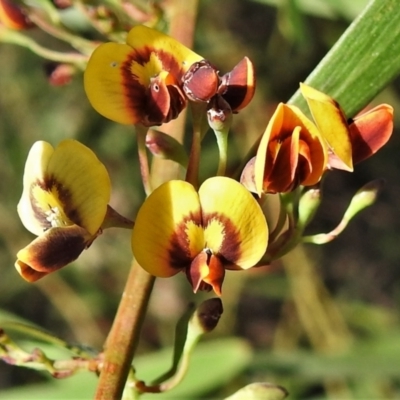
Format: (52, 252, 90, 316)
(16, 26, 393, 295)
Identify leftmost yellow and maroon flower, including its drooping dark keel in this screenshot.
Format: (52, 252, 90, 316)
(15, 140, 111, 282)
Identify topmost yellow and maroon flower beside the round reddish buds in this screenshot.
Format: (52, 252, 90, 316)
(84, 26, 202, 126)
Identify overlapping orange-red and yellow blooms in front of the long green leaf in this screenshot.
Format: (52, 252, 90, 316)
(241, 84, 393, 195)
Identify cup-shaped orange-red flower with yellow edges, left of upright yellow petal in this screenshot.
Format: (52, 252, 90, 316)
(241, 103, 327, 195)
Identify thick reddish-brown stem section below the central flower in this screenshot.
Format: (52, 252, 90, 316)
(95, 261, 155, 400)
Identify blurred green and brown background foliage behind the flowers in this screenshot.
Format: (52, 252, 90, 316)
(0, 0, 400, 399)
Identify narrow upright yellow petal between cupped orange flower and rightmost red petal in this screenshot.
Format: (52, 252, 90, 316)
(300, 84, 353, 171)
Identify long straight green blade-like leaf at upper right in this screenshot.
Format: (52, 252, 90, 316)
(289, 0, 400, 117)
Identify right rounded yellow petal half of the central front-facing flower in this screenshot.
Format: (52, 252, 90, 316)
(199, 177, 268, 269)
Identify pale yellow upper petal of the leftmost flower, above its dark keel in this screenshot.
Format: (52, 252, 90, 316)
(18, 140, 111, 235)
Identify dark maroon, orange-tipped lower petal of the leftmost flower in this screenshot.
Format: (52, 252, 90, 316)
(15, 225, 93, 282)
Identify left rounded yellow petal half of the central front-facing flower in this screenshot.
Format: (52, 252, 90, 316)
(132, 181, 204, 277)
